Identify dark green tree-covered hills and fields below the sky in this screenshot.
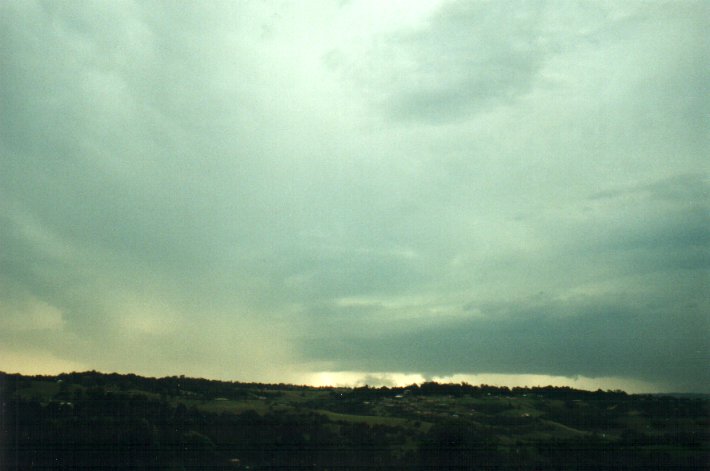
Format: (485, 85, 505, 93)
(0, 371, 710, 470)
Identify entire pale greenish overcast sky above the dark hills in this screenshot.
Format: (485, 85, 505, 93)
(0, 0, 710, 392)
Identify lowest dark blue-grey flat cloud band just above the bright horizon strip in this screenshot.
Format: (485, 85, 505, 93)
(303, 299, 710, 390)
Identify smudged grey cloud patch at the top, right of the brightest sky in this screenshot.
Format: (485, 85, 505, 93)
(328, 1, 624, 124)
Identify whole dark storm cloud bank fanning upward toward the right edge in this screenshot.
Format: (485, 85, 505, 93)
(304, 175, 710, 390)
